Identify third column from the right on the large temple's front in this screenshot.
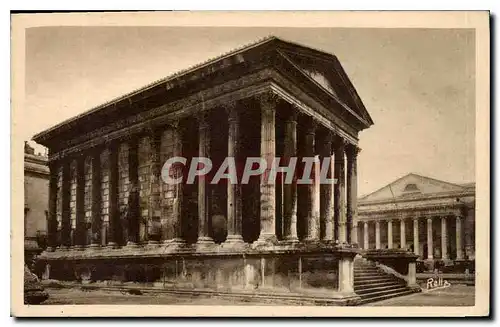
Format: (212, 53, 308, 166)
(319, 131, 334, 241)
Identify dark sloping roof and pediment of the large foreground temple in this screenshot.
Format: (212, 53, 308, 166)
(33, 36, 373, 144)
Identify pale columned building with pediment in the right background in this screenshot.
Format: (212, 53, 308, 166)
(358, 173, 475, 270)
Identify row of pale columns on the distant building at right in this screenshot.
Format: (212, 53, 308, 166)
(363, 215, 464, 259)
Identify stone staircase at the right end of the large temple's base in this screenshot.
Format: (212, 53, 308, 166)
(354, 258, 415, 304)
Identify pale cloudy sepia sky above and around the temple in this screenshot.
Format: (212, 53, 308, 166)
(24, 27, 475, 195)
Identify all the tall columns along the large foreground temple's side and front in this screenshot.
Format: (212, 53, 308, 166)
(48, 94, 358, 250)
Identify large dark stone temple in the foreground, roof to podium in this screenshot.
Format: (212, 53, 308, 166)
(34, 37, 422, 302)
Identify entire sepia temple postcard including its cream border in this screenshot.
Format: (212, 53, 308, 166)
(11, 11, 490, 316)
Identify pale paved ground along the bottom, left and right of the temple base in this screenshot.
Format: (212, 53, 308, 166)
(39, 285, 474, 306)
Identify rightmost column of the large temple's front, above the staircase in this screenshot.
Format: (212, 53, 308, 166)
(346, 144, 359, 244)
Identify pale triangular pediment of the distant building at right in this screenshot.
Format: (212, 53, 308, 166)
(361, 173, 465, 201)
